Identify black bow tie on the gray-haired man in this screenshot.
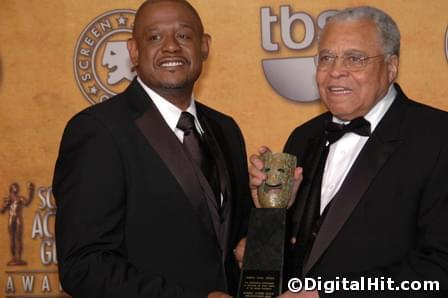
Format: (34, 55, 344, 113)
(325, 117, 370, 145)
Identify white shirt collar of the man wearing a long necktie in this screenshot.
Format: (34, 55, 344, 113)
(137, 76, 204, 134)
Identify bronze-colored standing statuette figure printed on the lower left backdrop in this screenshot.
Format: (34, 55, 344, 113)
(0, 182, 35, 266)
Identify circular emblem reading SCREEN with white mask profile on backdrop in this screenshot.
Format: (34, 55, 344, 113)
(73, 9, 135, 104)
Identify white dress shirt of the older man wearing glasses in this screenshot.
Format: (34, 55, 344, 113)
(320, 85, 397, 214)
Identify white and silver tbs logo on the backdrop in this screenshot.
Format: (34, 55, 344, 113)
(260, 6, 337, 102)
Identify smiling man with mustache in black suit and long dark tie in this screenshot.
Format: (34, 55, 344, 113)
(53, 0, 251, 298)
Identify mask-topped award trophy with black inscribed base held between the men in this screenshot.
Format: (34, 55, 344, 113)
(238, 152, 297, 298)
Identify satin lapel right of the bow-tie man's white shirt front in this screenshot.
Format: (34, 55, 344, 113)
(303, 86, 406, 275)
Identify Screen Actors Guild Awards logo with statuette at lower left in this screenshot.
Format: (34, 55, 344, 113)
(0, 182, 69, 297)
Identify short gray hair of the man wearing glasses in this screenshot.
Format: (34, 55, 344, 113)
(324, 6, 400, 57)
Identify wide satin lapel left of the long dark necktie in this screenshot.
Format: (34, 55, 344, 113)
(135, 98, 215, 234)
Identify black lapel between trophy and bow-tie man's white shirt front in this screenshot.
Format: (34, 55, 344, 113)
(291, 133, 325, 236)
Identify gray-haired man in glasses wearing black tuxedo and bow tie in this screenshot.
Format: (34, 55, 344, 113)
(250, 7, 448, 297)
